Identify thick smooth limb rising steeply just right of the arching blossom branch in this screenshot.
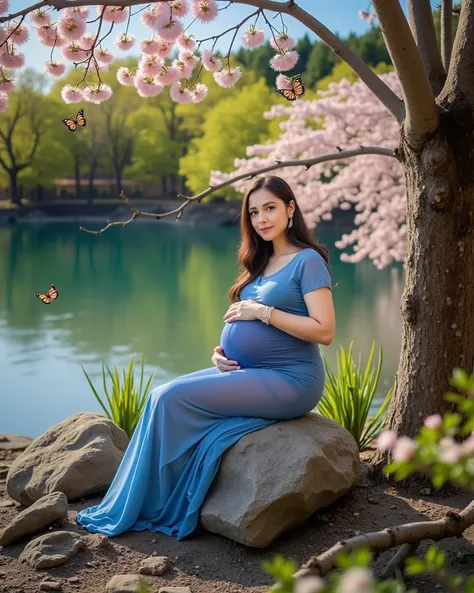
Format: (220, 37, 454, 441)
(372, 0, 438, 149)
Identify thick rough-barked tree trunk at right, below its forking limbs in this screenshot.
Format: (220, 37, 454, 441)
(372, 100, 474, 470)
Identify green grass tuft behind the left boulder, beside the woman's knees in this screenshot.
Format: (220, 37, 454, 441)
(81, 354, 154, 438)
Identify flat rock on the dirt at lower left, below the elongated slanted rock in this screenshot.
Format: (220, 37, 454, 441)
(19, 531, 84, 570)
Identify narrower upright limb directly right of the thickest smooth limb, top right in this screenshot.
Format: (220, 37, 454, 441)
(408, 0, 446, 97)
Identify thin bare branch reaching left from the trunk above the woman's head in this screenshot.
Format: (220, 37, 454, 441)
(80, 146, 397, 235)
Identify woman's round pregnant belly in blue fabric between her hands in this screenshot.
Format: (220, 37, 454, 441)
(220, 320, 319, 368)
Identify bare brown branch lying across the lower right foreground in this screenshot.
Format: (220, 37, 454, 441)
(294, 500, 474, 579)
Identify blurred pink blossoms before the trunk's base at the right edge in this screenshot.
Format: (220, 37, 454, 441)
(377, 414, 474, 465)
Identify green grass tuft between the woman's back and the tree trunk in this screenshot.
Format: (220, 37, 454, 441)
(317, 342, 393, 451)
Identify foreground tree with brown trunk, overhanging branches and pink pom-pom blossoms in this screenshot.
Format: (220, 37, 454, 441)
(0, 0, 474, 465)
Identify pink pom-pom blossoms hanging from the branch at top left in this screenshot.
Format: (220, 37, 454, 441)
(0, 0, 298, 110)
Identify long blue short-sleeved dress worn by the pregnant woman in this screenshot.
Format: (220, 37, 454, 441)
(76, 248, 331, 540)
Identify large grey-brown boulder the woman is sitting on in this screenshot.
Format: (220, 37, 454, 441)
(201, 413, 360, 548)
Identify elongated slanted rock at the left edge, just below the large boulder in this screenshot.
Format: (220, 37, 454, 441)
(0, 492, 67, 546)
